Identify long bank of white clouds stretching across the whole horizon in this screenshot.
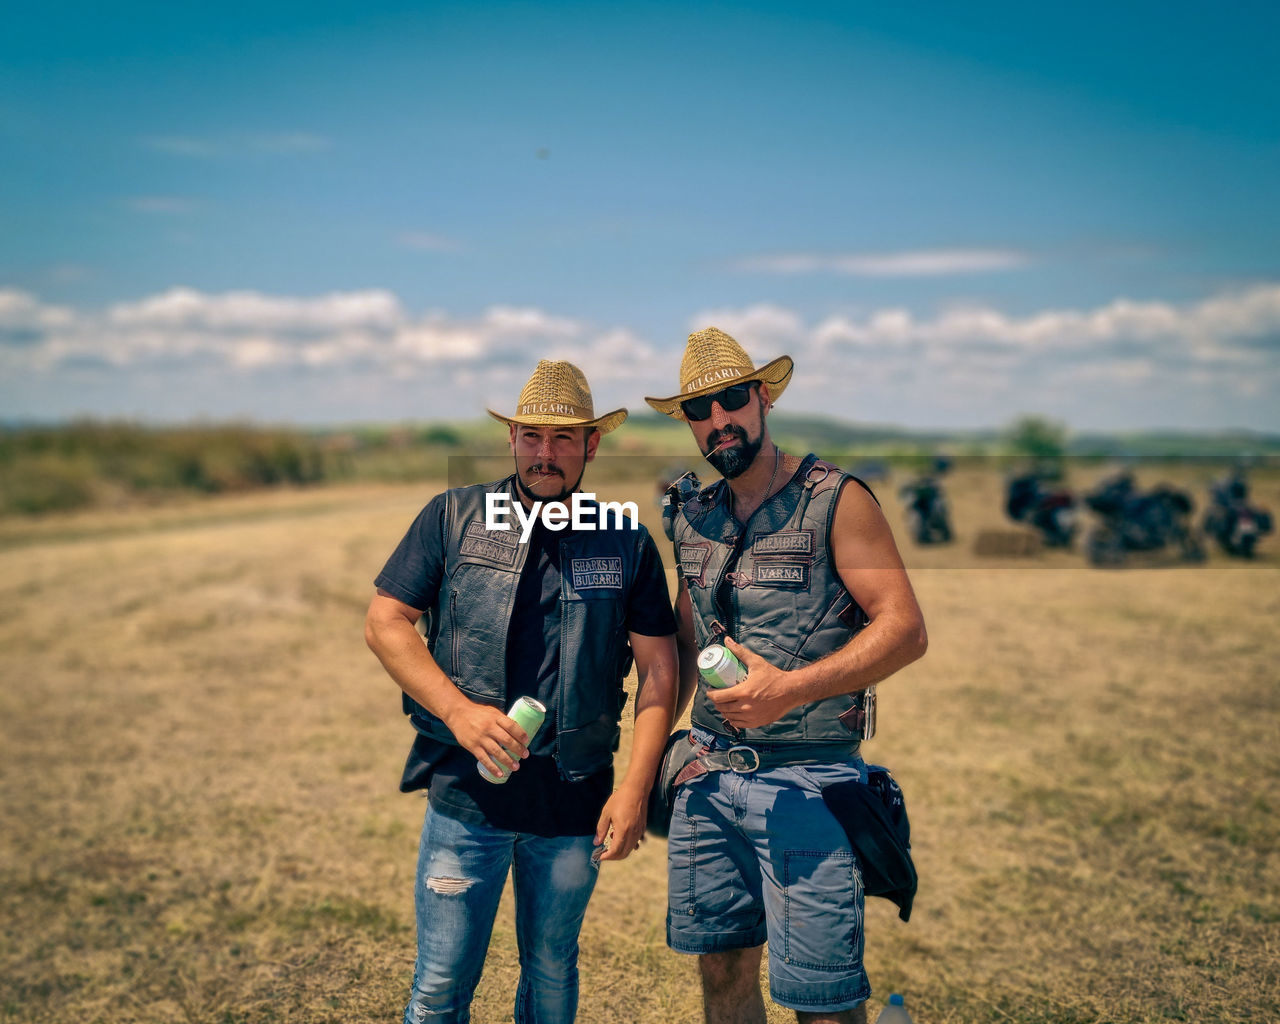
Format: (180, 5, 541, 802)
(0, 283, 1280, 429)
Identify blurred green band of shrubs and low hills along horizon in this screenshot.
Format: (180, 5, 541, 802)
(0, 412, 1280, 515)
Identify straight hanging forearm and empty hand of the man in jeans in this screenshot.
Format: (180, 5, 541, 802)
(595, 632, 676, 860)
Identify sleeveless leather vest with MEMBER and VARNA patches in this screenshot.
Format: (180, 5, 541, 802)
(675, 454, 868, 749)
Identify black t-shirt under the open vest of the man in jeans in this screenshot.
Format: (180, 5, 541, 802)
(375, 494, 676, 836)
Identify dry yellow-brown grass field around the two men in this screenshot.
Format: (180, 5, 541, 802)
(0, 468, 1280, 1024)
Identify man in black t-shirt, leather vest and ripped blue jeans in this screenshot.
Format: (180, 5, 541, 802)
(365, 360, 676, 1024)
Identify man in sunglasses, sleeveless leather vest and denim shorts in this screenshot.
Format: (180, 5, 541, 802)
(645, 328, 927, 1024)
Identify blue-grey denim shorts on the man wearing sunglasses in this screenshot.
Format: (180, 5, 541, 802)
(667, 731, 870, 1012)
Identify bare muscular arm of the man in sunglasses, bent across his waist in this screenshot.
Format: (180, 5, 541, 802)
(709, 484, 928, 728)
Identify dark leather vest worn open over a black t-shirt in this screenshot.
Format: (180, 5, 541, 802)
(404, 477, 649, 782)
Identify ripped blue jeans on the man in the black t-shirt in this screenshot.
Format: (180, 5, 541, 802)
(404, 806, 598, 1024)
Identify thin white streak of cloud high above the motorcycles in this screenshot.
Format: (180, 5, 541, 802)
(736, 248, 1032, 278)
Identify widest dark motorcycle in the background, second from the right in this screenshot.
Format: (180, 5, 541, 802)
(1084, 472, 1204, 566)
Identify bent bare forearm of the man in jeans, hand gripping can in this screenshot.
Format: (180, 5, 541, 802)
(365, 590, 529, 772)
